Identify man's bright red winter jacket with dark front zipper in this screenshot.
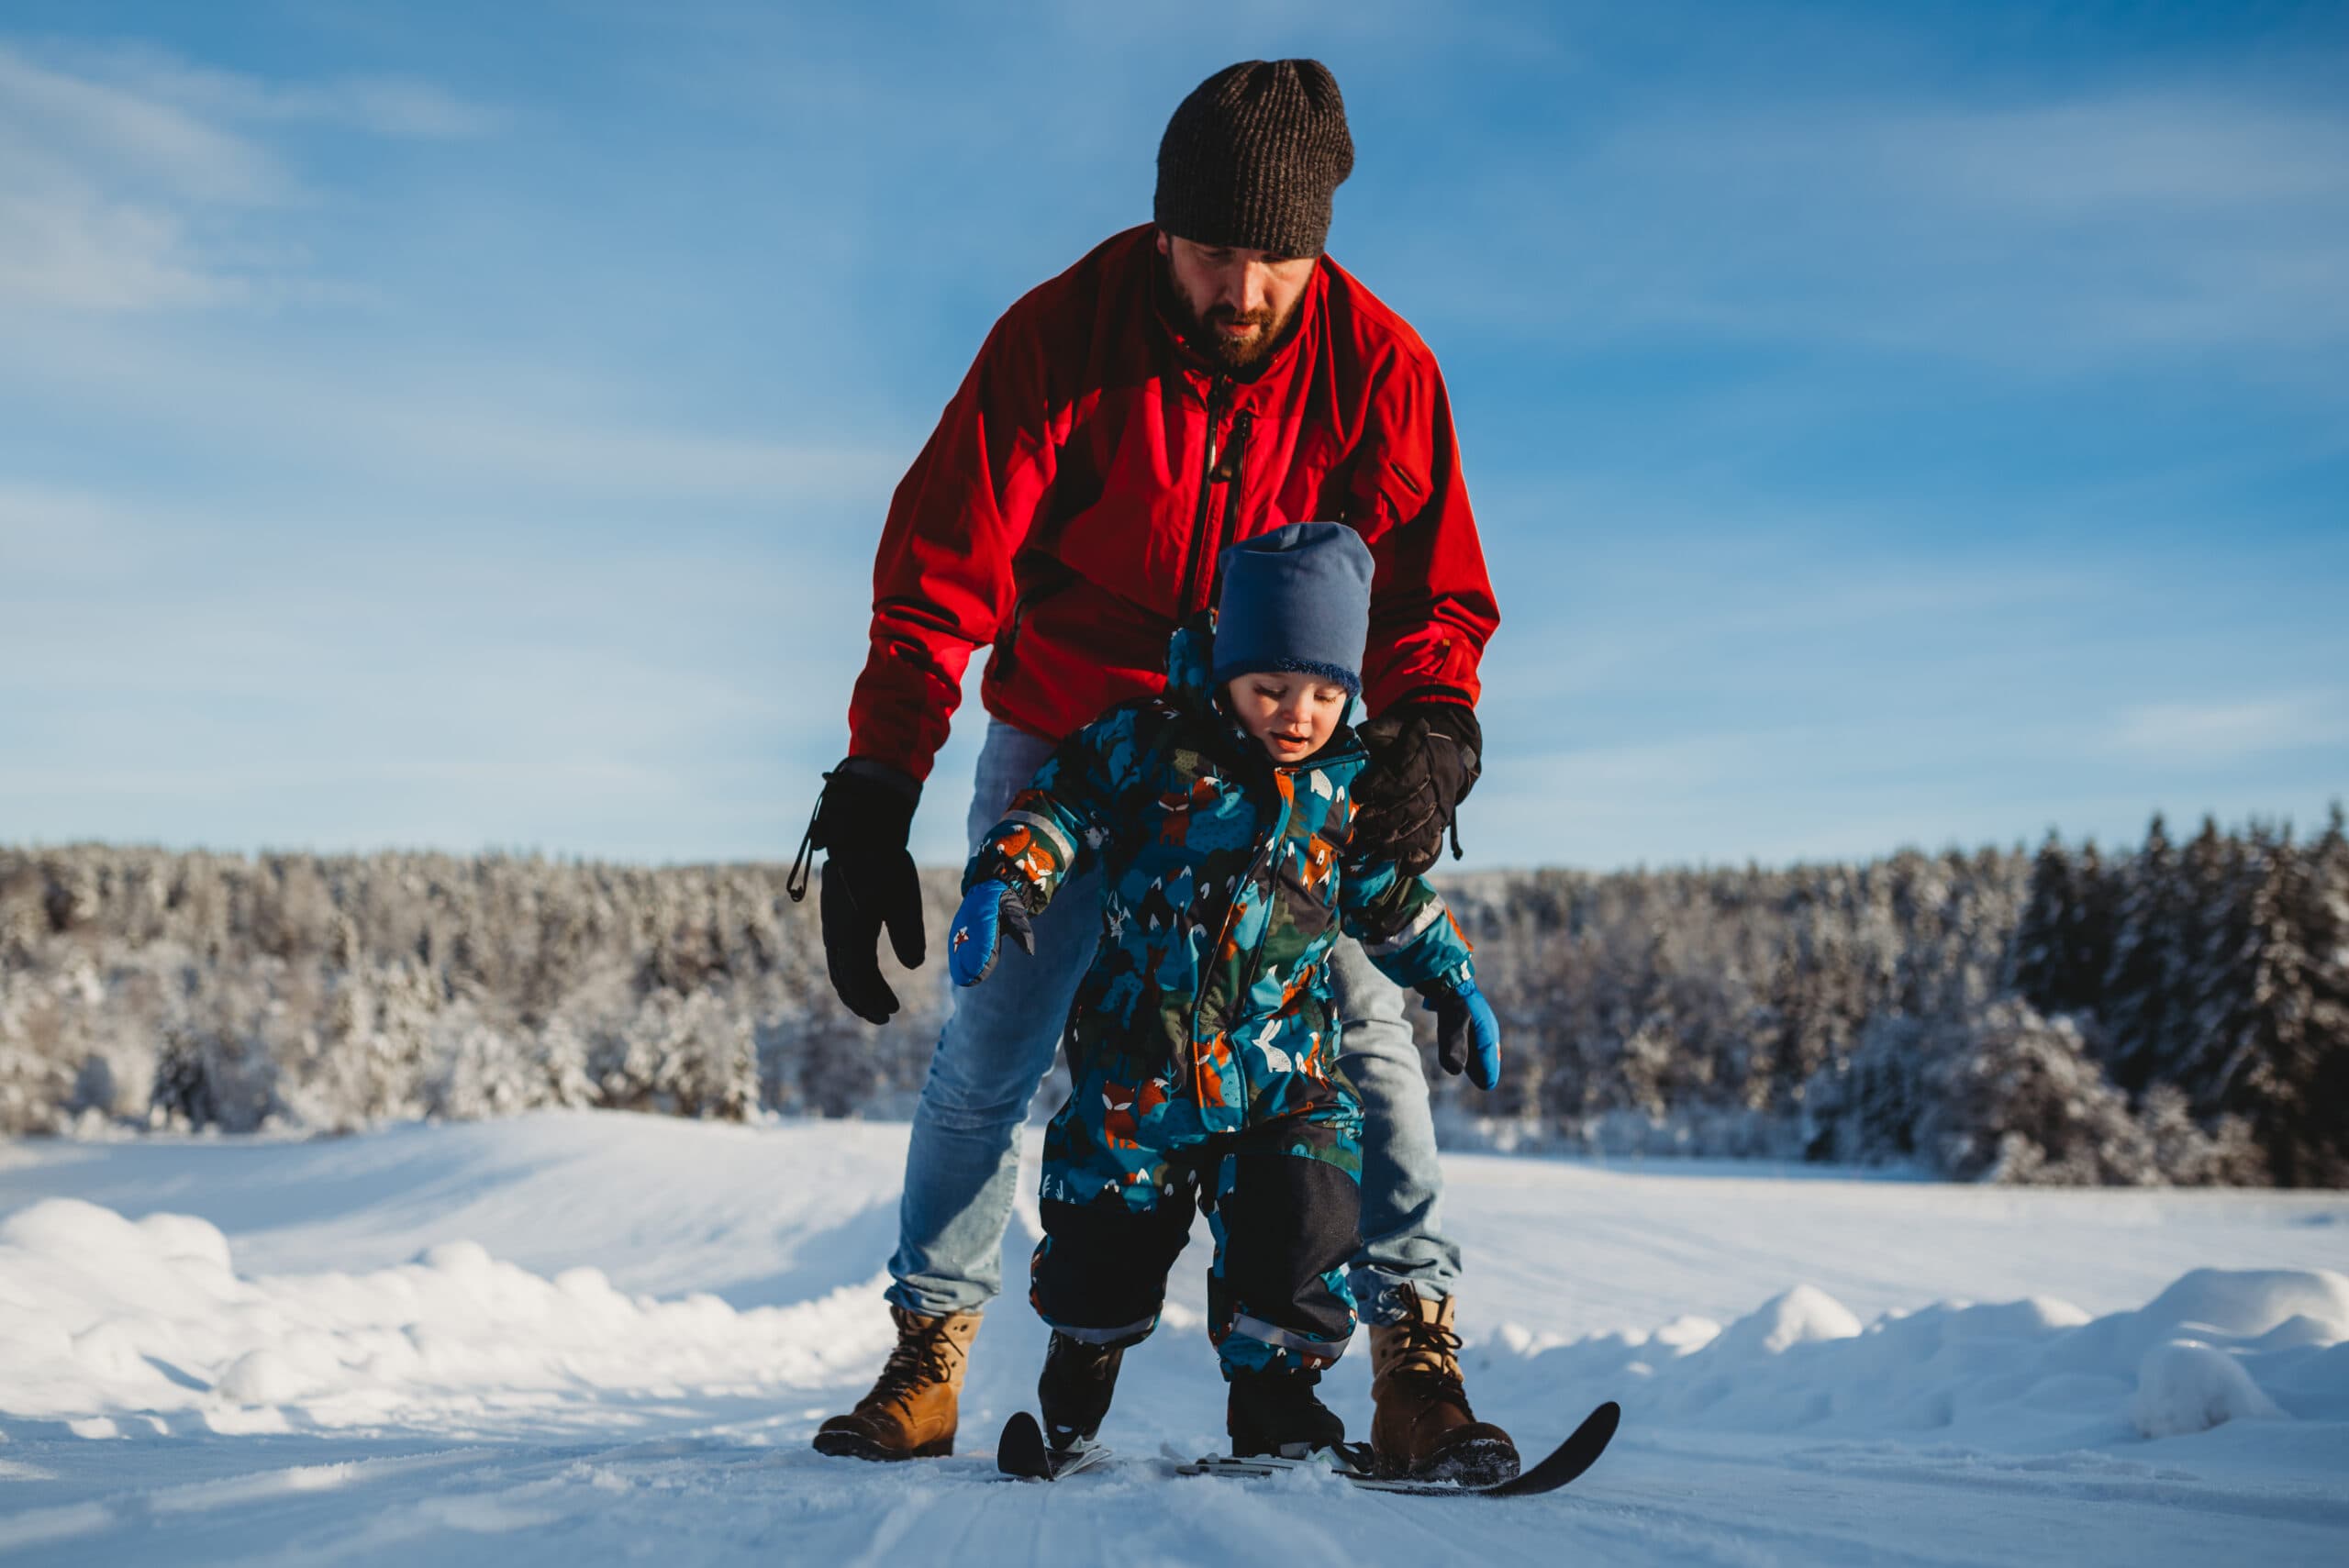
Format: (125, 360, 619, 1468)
(848, 226, 1498, 779)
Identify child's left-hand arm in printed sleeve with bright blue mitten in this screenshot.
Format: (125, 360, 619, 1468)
(947, 709, 1137, 986)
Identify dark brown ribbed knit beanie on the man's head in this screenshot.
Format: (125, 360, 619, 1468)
(1156, 61, 1353, 256)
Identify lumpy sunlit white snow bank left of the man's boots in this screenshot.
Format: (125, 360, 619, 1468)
(0, 1197, 890, 1437)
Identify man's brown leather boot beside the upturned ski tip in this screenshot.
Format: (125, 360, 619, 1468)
(1369, 1286, 1518, 1485)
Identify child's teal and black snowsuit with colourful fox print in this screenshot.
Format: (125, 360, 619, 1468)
(963, 617, 1473, 1375)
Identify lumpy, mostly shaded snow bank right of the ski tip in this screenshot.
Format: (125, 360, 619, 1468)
(1527, 1270, 2349, 1453)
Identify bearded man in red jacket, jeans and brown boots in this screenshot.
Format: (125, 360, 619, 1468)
(810, 61, 1515, 1479)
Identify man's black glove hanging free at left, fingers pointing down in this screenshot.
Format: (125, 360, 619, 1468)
(785, 756, 926, 1023)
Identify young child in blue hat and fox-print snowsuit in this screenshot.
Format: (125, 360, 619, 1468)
(947, 524, 1501, 1455)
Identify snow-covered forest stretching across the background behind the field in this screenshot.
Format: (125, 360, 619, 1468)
(0, 807, 2349, 1185)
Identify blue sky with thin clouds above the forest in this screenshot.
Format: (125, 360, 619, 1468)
(0, 0, 2349, 866)
